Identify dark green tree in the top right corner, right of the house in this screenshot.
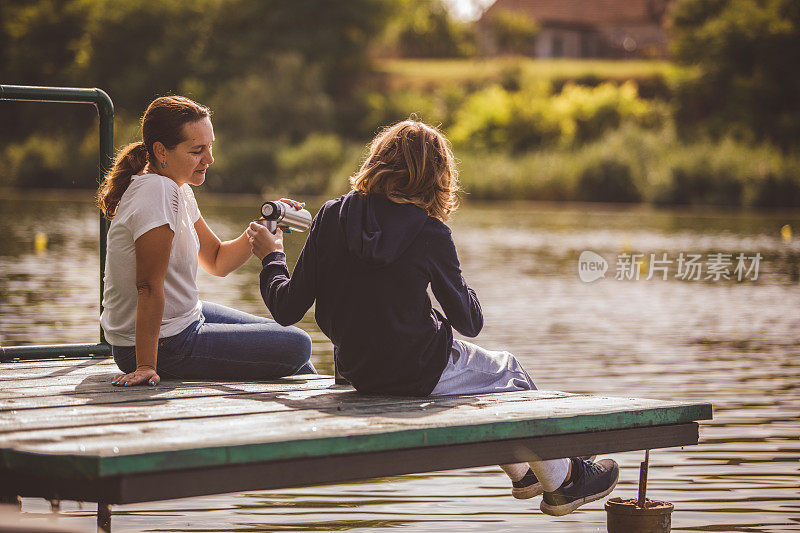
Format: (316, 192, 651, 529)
(671, 0, 800, 150)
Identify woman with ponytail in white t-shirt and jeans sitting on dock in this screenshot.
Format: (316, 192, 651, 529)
(97, 96, 315, 386)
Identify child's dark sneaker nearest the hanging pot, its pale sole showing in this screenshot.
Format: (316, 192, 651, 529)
(539, 457, 619, 516)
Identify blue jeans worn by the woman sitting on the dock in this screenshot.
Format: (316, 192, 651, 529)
(112, 302, 317, 380)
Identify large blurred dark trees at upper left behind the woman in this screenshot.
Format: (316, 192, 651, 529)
(0, 0, 393, 190)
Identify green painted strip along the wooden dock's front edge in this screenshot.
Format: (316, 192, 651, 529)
(0, 404, 712, 479)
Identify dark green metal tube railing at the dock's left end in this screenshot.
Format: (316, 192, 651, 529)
(0, 85, 114, 361)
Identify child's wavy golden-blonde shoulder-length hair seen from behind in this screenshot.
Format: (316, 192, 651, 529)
(350, 120, 460, 222)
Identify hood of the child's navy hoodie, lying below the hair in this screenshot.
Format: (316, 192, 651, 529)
(339, 191, 428, 266)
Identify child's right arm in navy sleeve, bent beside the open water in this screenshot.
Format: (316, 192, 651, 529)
(429, 230, 483, 337)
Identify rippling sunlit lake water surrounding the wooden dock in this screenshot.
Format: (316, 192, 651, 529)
(0, 191, 800, 533)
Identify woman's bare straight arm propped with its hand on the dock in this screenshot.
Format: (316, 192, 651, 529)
(113, 224, 173, 386)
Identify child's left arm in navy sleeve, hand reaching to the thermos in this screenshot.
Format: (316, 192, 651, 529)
(248, 220, 316, 326)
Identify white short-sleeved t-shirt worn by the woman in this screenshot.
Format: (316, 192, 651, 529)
(100, 174, 202, 346)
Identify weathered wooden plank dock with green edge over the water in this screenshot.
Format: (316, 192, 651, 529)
(0, 359, 711, 524)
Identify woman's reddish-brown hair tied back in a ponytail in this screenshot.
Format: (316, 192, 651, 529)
(97, 96, 211, 220)
